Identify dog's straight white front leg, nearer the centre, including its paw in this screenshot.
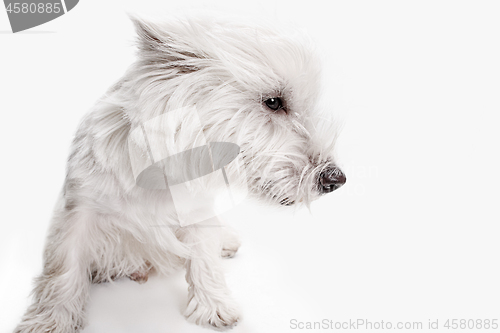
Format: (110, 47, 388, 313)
(181, 218, 239, 328)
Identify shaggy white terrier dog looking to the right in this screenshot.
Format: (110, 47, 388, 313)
(15, 19, 345, 333)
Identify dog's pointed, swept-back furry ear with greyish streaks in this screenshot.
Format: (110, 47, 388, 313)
(130, 16, 204, 62)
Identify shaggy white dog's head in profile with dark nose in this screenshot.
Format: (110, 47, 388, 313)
(122, 20, 345, 205)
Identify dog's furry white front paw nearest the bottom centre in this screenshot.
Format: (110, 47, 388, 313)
(184, 297, 240, 329)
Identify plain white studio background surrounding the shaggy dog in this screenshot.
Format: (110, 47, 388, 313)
(0, 0, 500, 333)
